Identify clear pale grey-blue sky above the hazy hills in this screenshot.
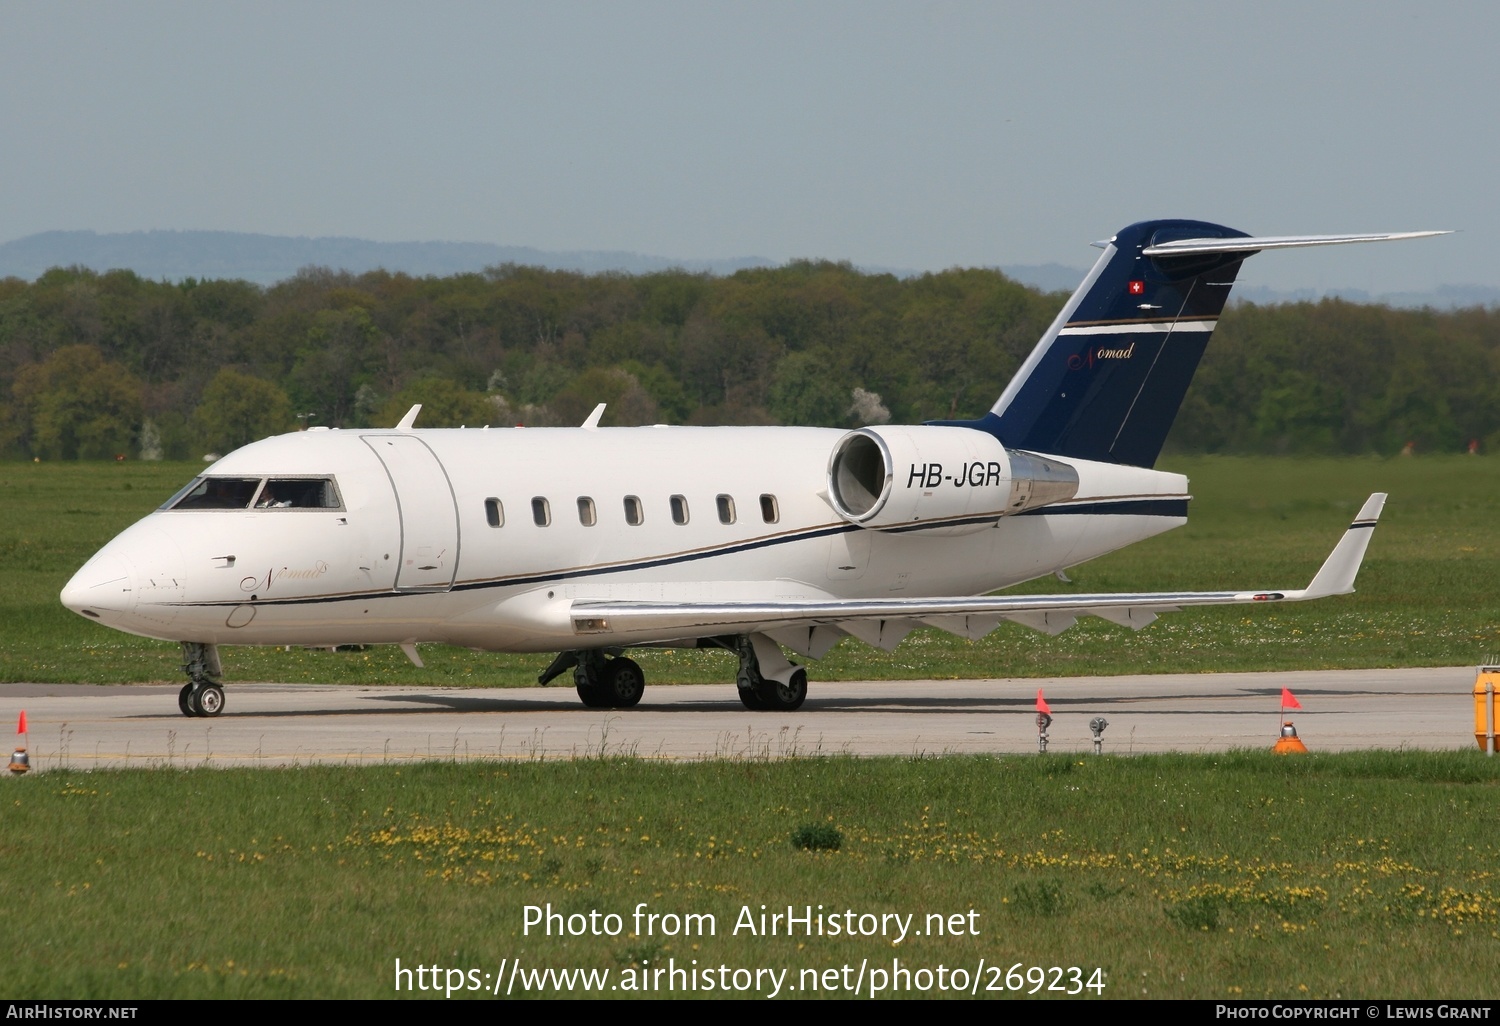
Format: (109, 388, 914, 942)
(0, 0, 1500, 293)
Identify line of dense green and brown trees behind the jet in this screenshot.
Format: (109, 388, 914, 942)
(0, 261, 1500, 459)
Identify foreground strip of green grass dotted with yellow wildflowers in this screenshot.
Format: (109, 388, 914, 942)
(0, 752, 1500, 999)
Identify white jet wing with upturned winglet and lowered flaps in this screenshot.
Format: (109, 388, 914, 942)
(570, 492, 1386, 659)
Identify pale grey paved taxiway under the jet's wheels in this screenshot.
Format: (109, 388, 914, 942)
(0, 666, 1475, 770)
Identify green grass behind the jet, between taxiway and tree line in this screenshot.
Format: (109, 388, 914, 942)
(0, 456, 1500, 687)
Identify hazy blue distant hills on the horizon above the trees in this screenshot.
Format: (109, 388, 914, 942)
(0, 231, 1500, 309)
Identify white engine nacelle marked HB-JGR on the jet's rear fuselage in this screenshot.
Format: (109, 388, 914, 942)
(828, 425, 1079, 534)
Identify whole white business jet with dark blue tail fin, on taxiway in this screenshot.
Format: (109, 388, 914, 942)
(62, 221, 1443, 716)
